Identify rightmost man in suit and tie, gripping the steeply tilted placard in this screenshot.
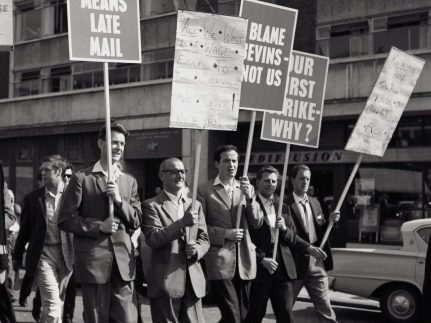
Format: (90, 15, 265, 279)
(287, 164, 340, 322)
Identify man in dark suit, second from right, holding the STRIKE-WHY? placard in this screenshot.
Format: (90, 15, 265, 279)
(245, 166, 323, 323)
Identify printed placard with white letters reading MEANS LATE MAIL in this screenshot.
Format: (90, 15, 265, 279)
(67, 0, 141, 63)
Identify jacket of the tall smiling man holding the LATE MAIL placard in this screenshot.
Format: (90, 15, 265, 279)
(58, 167, 141, 284)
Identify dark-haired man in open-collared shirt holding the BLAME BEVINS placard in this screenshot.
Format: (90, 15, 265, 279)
(198, 145, 263, 323)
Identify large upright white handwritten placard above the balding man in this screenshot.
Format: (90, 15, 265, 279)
(170, 10, 247, 130)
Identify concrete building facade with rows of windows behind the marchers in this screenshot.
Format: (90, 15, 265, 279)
(0, 0, 431, 245)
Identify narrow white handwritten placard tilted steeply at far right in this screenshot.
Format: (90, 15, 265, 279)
(345, 47, 425, 157)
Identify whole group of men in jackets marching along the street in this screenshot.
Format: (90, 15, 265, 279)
(0, 123, 339, 323)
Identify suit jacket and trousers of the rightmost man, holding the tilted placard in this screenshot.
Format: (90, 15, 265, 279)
(287, 193, 336, 322)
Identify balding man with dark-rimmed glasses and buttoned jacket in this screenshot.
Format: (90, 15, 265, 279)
(142, 158, 209, 323)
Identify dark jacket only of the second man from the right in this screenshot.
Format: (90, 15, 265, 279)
(250, 196, 310, 281)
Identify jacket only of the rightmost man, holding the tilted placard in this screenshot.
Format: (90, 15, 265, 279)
(287, 193, 334, 279)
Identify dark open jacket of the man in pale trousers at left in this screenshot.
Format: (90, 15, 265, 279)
(13, 187, 73, 280)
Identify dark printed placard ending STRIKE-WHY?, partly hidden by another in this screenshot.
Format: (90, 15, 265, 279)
(261, 50, 329, 148)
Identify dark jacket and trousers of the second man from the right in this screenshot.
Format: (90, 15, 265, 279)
(245, 196, 310, 323)
